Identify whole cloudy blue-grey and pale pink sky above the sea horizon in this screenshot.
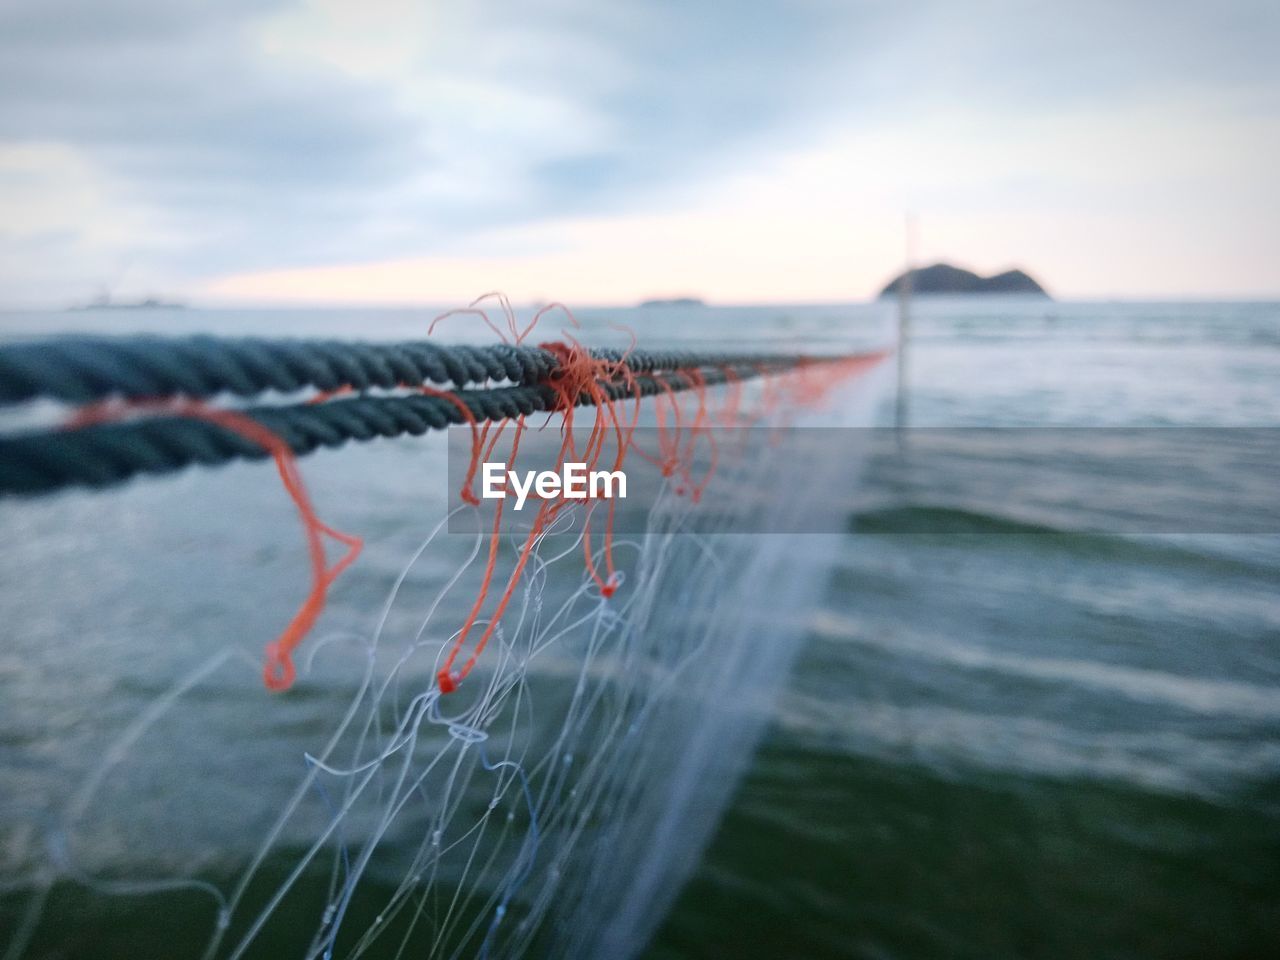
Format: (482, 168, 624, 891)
(0, 0, 1280, 306)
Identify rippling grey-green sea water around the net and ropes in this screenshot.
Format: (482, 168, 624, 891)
(0, 300, 1280, 960)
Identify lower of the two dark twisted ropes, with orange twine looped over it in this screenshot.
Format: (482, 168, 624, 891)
(0, 360, 809, 494)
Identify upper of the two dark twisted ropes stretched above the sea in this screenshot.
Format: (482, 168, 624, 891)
(0, 337, 819, 406)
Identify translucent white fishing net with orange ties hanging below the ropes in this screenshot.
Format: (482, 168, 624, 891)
(0, 305, 879, 959)
